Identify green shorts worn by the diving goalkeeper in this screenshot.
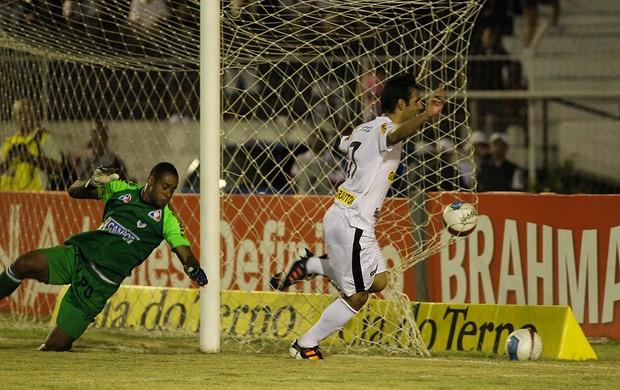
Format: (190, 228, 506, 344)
(41, 245, 119, 340)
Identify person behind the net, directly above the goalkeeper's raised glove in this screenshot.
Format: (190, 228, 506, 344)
(73, 121, 128, 180)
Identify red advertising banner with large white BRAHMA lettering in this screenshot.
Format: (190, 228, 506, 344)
(428, 193, 620, 339)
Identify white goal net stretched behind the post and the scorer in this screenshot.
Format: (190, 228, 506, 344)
(0, 0, 482, 355)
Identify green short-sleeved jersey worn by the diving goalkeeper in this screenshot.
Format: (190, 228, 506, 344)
(65, 180, 189, 284)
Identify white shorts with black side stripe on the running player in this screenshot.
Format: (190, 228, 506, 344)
(323, 206, 387, 297)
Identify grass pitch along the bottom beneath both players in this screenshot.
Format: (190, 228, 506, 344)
(0, 321, 620, 389)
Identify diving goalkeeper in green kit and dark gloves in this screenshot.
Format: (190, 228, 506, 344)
(0, 162, 208, 351)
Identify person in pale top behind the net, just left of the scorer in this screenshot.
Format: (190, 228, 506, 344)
(290, 128, 344, 195)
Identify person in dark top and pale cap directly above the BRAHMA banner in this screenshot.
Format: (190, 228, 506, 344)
(476, 132, 525, 192)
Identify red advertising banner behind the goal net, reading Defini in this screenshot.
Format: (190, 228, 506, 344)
(0, 192, 415, 315)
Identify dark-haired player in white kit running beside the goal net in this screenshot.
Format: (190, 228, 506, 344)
(271, 74, 447, 360)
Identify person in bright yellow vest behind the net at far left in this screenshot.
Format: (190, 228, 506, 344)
(0, 99, 63, 190)
